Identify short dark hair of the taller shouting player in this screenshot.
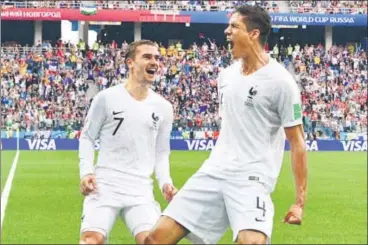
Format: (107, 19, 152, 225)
(234, 5, 272, 46)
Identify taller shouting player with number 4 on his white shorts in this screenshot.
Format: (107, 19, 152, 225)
(145, 5, 307, 244)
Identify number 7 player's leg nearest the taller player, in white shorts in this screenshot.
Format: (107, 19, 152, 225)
(120, 200, 161, 244)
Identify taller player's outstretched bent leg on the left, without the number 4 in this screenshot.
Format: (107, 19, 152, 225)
(145, 173, 229, 244)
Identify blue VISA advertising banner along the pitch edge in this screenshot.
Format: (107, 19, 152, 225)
(1, 139, 367, 151)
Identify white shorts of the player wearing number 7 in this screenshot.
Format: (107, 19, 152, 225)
(80, 187, 161, 239)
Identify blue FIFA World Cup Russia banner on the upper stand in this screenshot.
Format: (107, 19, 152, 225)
(180, 11, 367, 27)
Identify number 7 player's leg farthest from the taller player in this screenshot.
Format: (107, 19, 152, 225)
(79, 194, 119, 244)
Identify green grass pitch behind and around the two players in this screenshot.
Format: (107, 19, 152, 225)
(1, 151, 367, 244)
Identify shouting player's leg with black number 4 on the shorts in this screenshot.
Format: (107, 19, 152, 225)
(224, 181, 274, 244)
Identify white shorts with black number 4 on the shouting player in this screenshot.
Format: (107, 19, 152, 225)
(163, 172, 274, 244)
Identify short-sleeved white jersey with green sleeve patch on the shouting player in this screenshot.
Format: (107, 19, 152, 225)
(200, 59, 302, 190)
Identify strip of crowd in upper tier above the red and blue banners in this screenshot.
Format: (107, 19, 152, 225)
(1, 0, 367, 14)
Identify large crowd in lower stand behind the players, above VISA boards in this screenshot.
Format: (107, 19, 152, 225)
(1, 38, 367, 138)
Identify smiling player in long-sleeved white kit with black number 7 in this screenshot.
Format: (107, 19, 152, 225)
(79, 40, 177, 244)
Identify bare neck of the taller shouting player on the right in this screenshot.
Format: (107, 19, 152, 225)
(242, 47, 270, 76)
